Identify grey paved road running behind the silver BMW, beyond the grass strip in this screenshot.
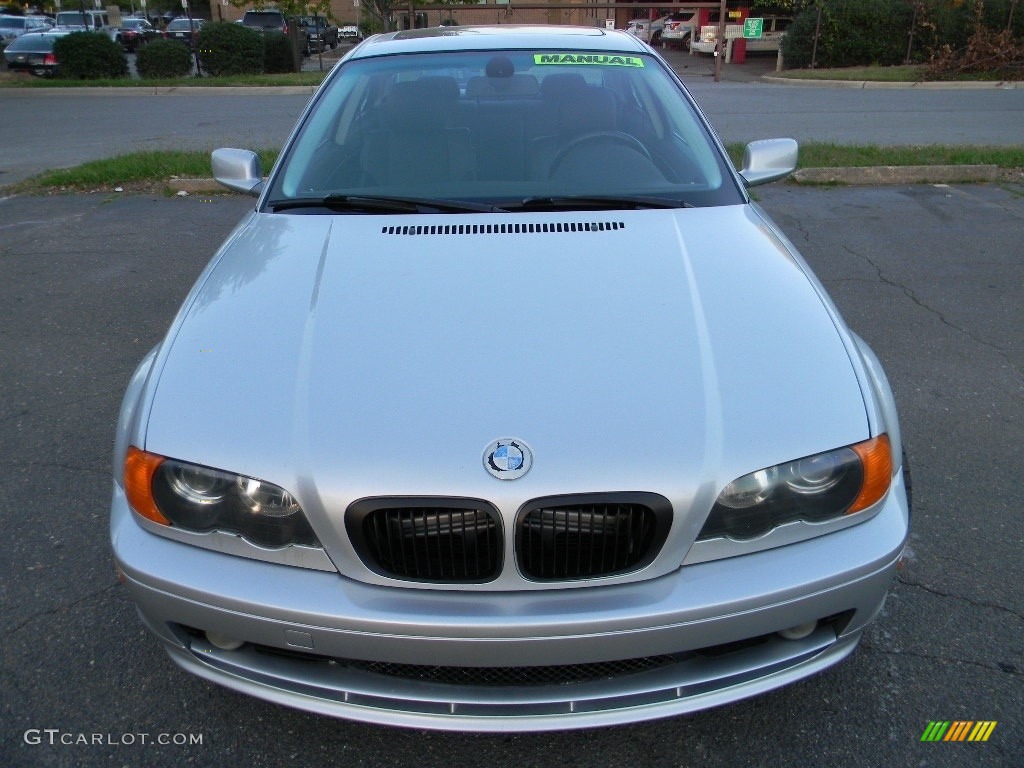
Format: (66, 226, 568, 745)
(0, 51, 1024, 184)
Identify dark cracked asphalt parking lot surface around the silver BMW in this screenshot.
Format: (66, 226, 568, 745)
(0, 183, 1024, 768)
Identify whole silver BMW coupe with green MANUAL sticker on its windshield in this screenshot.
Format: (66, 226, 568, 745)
(111, 27, 909, 731)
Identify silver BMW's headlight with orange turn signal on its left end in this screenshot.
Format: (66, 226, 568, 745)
(125, 446, 321, 547)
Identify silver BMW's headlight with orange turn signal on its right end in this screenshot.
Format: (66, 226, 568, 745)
(697, 435, 893, 541)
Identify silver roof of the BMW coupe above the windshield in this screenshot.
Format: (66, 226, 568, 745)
(352, 25, 647, 58)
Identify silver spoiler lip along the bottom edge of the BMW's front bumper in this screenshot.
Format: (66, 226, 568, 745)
(157, 627, 860, 732)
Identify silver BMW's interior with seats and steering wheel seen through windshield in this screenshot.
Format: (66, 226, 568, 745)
(283, 54, 722, 204)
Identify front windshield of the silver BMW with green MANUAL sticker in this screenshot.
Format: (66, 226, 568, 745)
(266, 50, 742, 208)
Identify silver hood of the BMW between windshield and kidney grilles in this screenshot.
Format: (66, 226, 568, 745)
(144, 206, 868, 518)
